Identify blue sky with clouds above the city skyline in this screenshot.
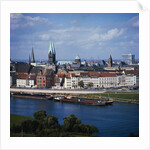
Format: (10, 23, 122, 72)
(10, 13, 139, 60)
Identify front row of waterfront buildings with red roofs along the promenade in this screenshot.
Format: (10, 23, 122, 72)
(10, 69, 139, 89)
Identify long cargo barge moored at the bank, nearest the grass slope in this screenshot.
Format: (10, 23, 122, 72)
(54, 96, 113, 106)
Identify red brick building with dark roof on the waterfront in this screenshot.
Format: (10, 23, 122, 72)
(36, 69, 54, 88)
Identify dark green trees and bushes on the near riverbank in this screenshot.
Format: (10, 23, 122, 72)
(10, 110, 98, 137)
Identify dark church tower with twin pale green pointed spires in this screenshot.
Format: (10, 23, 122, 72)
(48, 41, 56, 64)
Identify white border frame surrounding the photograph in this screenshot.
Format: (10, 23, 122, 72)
(0, 0, 149, 149)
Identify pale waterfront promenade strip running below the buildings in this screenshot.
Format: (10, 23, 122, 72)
(10, 88, 106, 94)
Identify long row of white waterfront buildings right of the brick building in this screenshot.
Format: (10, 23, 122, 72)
(64, 72, 139, 89)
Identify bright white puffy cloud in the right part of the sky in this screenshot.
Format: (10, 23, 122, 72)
(100, 28, 124, 41)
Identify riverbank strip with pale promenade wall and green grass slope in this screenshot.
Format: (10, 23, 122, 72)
(10, 88, 139, 104)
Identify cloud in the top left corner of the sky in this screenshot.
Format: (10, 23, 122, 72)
(10, 13, 51, 29)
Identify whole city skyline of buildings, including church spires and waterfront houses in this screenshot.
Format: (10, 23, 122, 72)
(10, 42, 139, 89)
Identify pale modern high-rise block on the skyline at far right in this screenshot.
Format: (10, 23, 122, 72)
(122, 54, 135, 65)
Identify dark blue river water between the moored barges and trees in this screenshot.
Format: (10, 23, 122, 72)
(10, 97, 139, 137)
